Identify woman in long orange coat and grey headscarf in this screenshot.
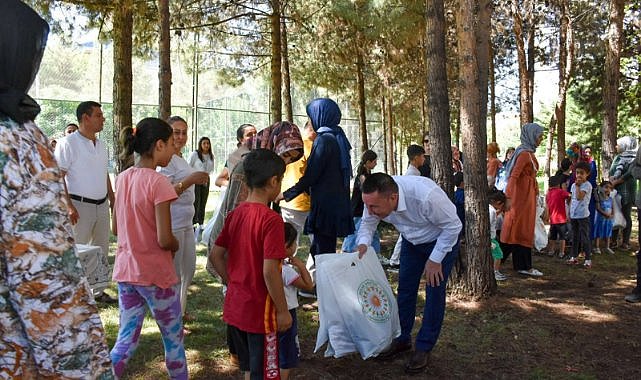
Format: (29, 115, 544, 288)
(501, 123, 543, 276)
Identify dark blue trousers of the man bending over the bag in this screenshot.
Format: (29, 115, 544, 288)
(396, 239, 459, 351)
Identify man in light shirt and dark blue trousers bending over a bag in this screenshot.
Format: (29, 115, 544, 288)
(356, 173, 461, 373)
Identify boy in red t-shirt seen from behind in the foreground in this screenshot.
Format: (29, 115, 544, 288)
(209, 149, 292, 379)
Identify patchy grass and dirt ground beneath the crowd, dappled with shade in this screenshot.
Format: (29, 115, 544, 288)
(100, 191, 641, 380)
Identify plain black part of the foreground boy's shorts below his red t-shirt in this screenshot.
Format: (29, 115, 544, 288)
(229, 325, 265, 378)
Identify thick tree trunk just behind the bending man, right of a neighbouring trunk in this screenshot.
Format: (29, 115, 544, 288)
(456, 0, 496, 299)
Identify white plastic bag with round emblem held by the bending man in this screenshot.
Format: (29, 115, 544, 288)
(314, 247, 401, 359)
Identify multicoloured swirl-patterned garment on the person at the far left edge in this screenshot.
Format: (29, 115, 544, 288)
(0, 113, 113, 379)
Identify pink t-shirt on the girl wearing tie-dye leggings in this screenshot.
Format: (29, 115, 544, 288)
(113, 167, 178, 289)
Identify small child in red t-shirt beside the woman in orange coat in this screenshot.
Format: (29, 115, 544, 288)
(545, 174, 570, 258)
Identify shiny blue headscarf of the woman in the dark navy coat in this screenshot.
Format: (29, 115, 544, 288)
(306, 98, 352, 187)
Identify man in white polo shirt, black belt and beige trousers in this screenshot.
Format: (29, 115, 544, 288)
(55, 101, 117, 303)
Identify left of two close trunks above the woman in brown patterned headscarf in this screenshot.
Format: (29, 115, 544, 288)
(269, 0, 283, 123)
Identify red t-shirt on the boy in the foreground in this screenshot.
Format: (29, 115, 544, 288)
(216, 202, 287, 334)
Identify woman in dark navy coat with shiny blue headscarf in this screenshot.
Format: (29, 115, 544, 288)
(283, 98, 354, 257)
